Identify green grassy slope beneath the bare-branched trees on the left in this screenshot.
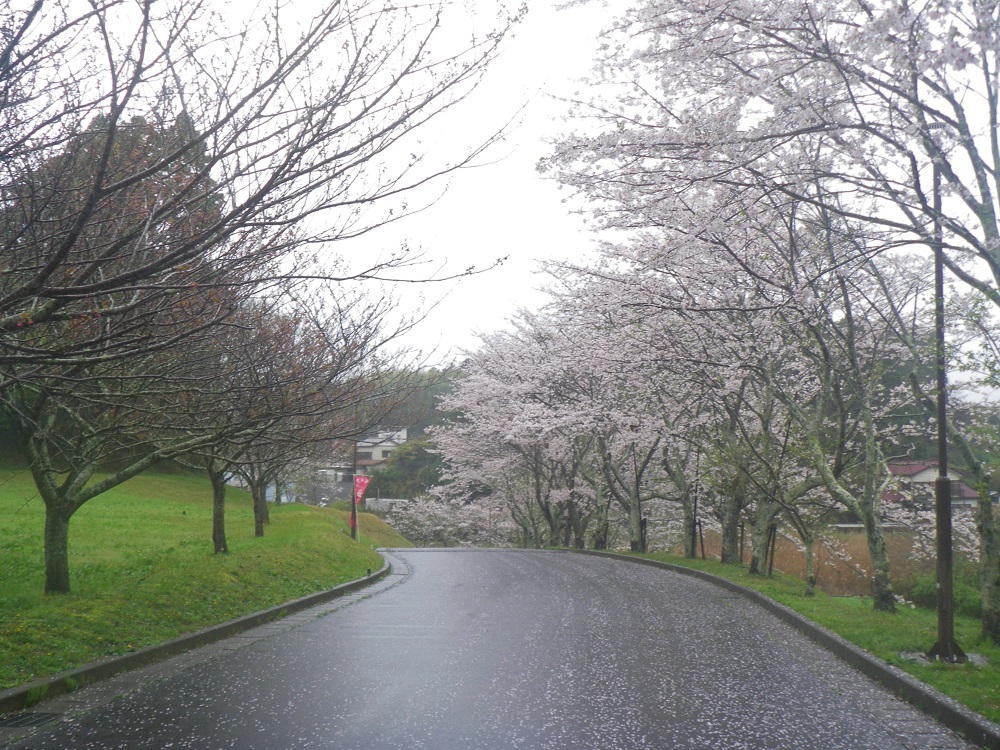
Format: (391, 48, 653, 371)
(0, 468, 409, 689)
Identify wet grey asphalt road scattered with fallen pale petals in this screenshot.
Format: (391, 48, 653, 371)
(5, 550, 967, 750)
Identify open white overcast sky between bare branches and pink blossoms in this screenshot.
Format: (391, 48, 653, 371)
(345, 0, 608, 362)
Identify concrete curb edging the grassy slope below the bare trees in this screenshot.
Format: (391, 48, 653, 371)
(0, 559, 391, 714)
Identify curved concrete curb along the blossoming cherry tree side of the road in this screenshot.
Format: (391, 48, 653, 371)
(567, 550, 1000, 750)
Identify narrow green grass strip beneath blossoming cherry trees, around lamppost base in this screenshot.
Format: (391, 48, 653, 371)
(643, 553, 1000, 722)
